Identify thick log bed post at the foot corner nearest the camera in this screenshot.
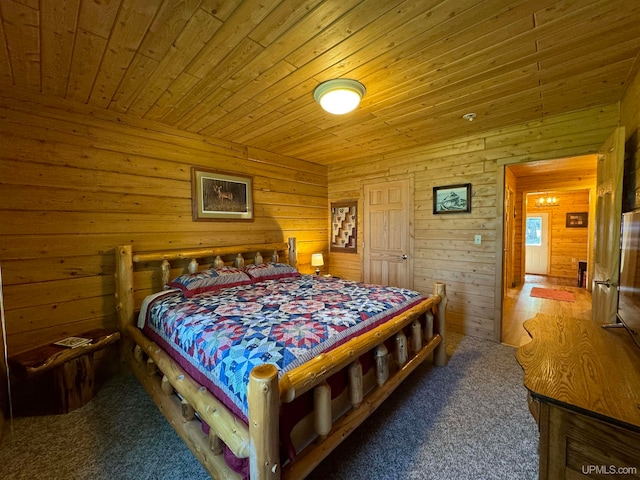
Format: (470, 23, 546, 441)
(247, 363, 281, 480)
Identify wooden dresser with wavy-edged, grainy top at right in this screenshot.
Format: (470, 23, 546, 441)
(516, 314, 640, 480)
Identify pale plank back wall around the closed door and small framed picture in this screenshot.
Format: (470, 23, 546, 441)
(329, 105, 618, 340)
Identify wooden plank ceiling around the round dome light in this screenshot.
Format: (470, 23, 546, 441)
(0, 0, 640, 164)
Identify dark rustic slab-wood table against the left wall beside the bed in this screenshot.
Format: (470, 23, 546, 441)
(9, 329, 120, 415)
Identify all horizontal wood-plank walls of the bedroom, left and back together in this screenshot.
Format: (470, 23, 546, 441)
(0, 63, 640, 353)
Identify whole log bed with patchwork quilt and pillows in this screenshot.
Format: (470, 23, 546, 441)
(116, 238, 447, 479)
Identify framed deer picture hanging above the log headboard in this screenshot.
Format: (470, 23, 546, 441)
(191, 167, 253, 221)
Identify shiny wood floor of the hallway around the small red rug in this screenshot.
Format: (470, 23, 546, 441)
(502, 275, 591, 347)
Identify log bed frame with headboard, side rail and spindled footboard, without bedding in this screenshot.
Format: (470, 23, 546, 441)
(116, 238, 447, 480)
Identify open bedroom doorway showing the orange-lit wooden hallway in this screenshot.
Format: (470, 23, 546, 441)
(500, 155, 597, 346)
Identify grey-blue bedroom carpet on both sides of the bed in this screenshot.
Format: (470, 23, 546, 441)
(0, 334, 538, 480)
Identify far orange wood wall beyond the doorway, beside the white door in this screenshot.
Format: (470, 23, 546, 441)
(526, 190, 590, 278)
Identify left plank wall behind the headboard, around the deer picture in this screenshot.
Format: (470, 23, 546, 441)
(0, 93, 329, 353)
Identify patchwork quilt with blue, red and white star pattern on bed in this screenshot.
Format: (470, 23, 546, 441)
(139, 275, 426, 421)
